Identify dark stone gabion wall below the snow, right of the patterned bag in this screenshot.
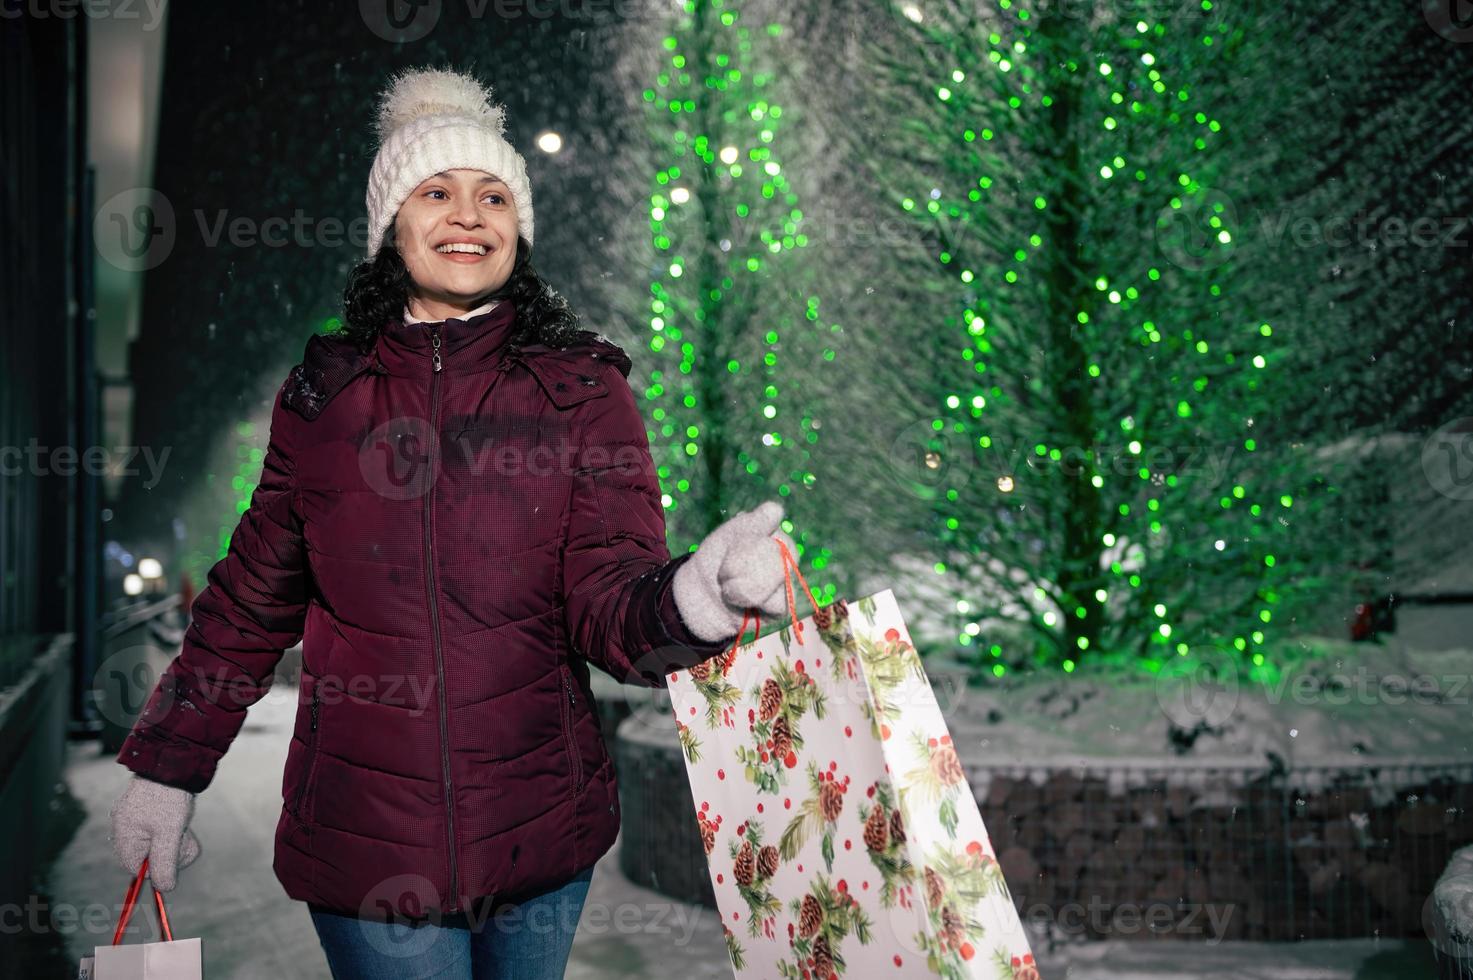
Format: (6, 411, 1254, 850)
(972, 766, 1473, 940)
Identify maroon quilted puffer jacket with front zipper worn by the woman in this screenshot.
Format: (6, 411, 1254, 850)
(118, 301, 725, 920)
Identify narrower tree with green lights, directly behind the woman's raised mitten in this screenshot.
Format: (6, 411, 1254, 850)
(595, 0, 843, 604)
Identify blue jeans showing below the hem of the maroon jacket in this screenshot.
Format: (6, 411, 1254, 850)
(308, 867, 594, 980)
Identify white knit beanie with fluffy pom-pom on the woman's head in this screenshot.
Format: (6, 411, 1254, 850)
(368, 68, 532, 259)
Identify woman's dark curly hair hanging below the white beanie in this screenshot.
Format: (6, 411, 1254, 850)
(330, 224, 591, 352)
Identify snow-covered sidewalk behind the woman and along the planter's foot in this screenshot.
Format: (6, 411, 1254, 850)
(47, 685, 1433, 980)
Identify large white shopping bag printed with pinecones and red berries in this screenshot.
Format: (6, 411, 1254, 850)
(669, 541, 1038, 980)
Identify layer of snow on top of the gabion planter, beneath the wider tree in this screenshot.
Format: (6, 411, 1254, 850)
(927, 630, 1473, 788)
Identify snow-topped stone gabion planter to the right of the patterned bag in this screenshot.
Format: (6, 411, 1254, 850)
(932, 647, 1473, 942)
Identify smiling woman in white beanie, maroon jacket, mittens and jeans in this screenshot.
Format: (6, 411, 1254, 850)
(113, 71, 795, 980)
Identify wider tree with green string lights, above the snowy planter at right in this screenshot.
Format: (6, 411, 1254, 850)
(830, 0, 1333, 675)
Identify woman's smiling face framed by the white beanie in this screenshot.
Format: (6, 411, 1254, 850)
(393, 169, 517, 320)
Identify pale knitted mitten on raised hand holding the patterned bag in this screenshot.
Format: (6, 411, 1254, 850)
(670, 500, 798, 640)
